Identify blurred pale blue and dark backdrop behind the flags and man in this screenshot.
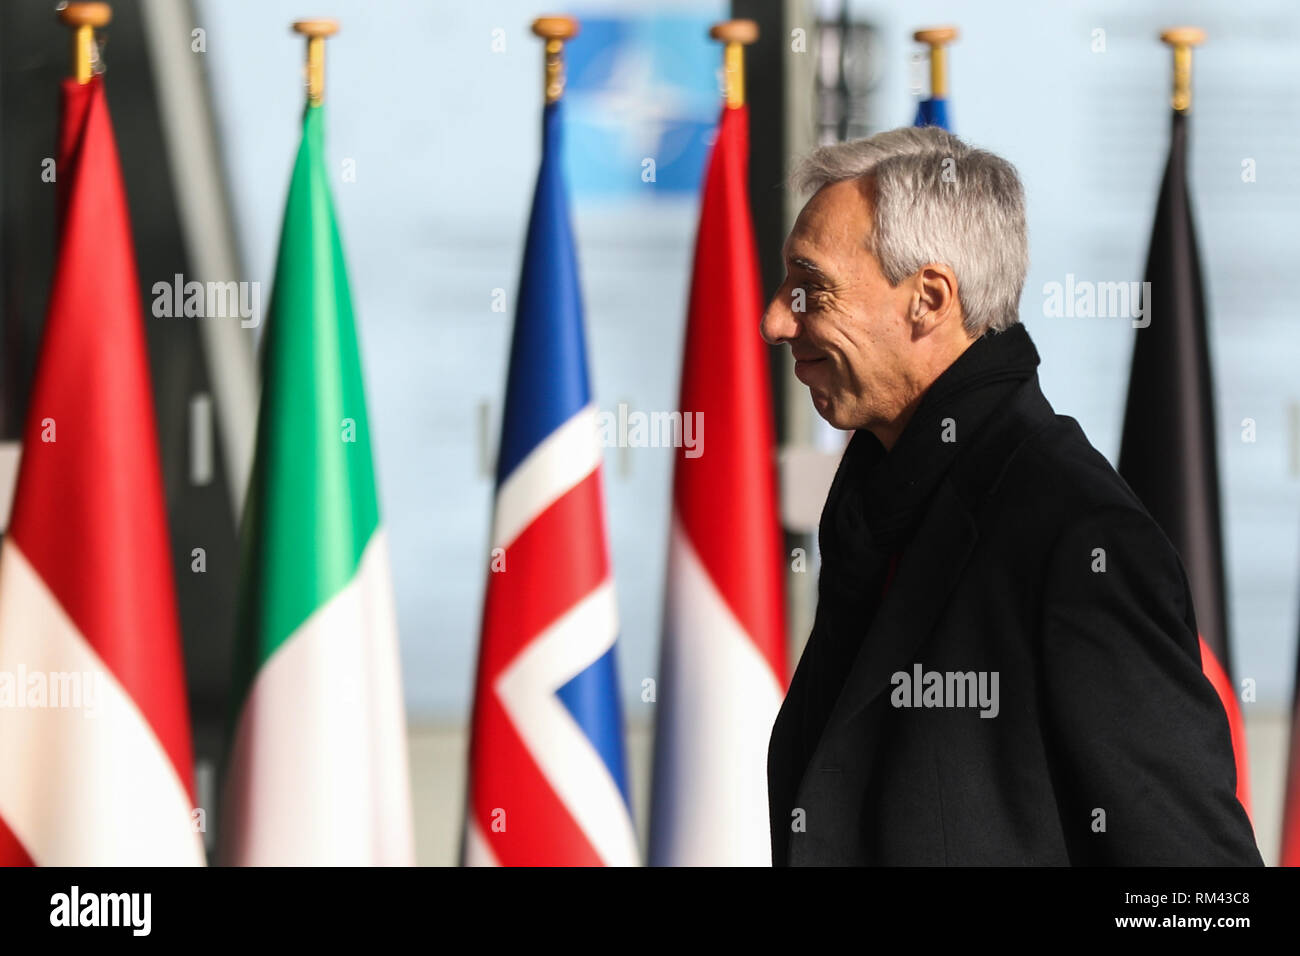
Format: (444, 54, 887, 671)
(0, 0, 1300, 864)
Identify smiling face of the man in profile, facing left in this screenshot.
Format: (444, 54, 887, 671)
(761, 181, 915, 429)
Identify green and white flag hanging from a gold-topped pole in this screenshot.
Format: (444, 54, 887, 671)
(221, 105, 413, 865)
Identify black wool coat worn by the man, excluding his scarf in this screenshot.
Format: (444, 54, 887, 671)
(768, 375, 1261, 865)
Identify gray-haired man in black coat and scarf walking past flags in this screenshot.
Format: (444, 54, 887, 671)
(762, 127, 1261, 865)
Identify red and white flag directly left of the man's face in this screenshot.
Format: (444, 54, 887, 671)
(650, 105, 787, 866)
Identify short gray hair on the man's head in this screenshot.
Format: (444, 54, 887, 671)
(790, 126, 1030, 337)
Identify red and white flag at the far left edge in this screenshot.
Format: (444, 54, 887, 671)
(0, 77, 204, 865)
